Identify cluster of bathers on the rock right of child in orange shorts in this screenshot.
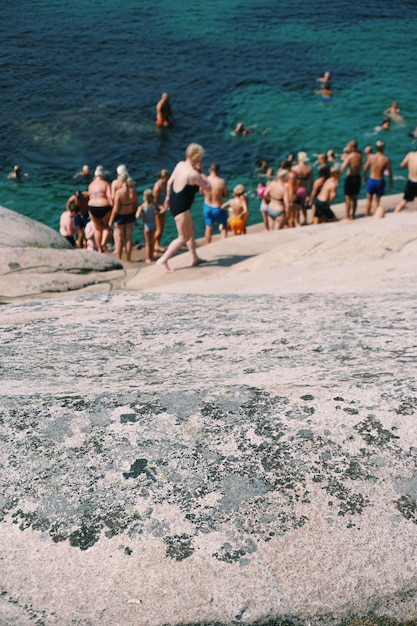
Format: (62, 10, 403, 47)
(257, 130, 417, 230)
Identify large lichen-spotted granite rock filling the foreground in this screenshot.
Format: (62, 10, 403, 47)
(0, 291, 417, 626)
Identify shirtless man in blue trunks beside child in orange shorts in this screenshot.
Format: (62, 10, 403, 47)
(200, 163, 229, 243)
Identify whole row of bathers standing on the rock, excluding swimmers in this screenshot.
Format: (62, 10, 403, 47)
(48, 130, 417, 272)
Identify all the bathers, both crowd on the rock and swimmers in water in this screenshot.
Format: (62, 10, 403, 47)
(8, 90, 417, 272)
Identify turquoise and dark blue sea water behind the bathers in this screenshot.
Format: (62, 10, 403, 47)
(0, 0, 417, 242)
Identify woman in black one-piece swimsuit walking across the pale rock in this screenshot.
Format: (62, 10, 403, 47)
(156, 143, 211, 273)
